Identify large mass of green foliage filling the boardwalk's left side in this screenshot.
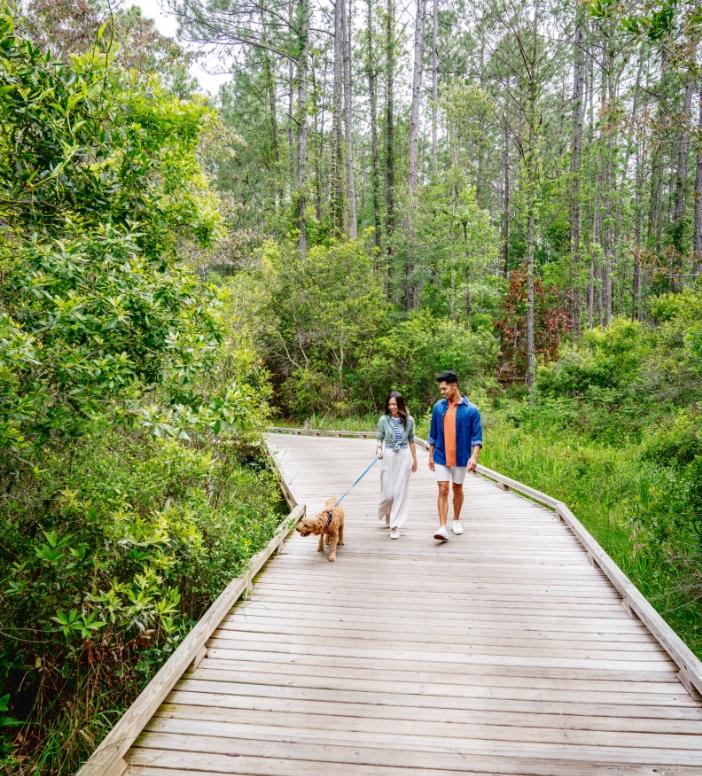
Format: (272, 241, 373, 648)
(0, 15, 281, 773)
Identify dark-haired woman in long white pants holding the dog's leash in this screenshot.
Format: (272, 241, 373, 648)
(376, 391, 417, 539)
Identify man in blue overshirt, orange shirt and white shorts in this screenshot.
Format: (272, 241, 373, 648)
(428, 372, 483, 542)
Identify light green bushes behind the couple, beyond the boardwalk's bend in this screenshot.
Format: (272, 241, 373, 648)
(264, 242, 498, 417)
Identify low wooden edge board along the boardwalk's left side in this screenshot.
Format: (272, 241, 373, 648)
(76, 498, 305, 776)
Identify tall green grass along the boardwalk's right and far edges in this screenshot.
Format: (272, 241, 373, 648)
(284, 410, 702, 658)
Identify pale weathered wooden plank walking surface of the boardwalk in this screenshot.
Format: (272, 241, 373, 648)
(114, 435, 702, 776)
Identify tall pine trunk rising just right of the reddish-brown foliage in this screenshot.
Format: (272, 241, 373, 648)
(569, 3, 585, 336)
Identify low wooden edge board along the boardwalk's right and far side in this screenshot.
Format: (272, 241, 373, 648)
(278, 426, 702, 701)
